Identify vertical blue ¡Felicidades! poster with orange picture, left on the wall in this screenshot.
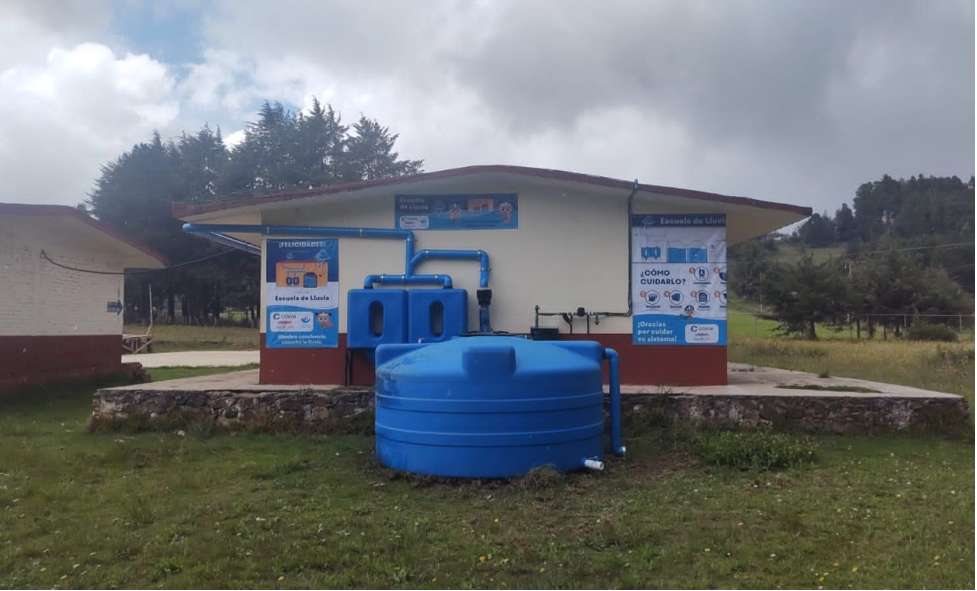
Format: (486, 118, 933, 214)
(265, 240, 339, 349)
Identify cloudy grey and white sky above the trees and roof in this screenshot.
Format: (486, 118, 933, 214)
(0, 0, 975, 210)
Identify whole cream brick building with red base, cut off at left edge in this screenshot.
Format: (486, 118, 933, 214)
(0, 203, 165, 390)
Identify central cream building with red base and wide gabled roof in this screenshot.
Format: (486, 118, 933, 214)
(174, 166, 811, 384)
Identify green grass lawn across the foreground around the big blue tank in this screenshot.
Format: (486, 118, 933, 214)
(0, 364, 975, 589)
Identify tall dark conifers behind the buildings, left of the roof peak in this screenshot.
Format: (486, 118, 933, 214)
(79, 99, 423, 325)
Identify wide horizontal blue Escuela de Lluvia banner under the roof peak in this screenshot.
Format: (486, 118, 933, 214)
(394, 193, 519, 230)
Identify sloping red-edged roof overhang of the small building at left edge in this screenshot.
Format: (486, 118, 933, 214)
(0, 203, 167, 269)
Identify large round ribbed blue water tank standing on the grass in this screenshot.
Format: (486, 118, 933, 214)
(376, 336, 604, 478)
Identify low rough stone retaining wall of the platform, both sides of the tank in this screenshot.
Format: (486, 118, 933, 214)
(92, 384, 970, 434)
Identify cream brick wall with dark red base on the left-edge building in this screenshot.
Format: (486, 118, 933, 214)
(0, 216, 123, 390)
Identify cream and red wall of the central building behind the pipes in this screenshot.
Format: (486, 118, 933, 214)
(261, 185, 726, 384)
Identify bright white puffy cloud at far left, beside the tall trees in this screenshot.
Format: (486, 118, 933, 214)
(0, 43, 180, 204)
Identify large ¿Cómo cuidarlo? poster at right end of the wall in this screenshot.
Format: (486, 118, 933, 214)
(631, 214, 726, 345)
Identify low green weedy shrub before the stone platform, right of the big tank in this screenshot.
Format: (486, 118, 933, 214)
(692, 430, 818, 470)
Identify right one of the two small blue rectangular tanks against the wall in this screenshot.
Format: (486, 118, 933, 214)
(407, 289, 468, 343)
